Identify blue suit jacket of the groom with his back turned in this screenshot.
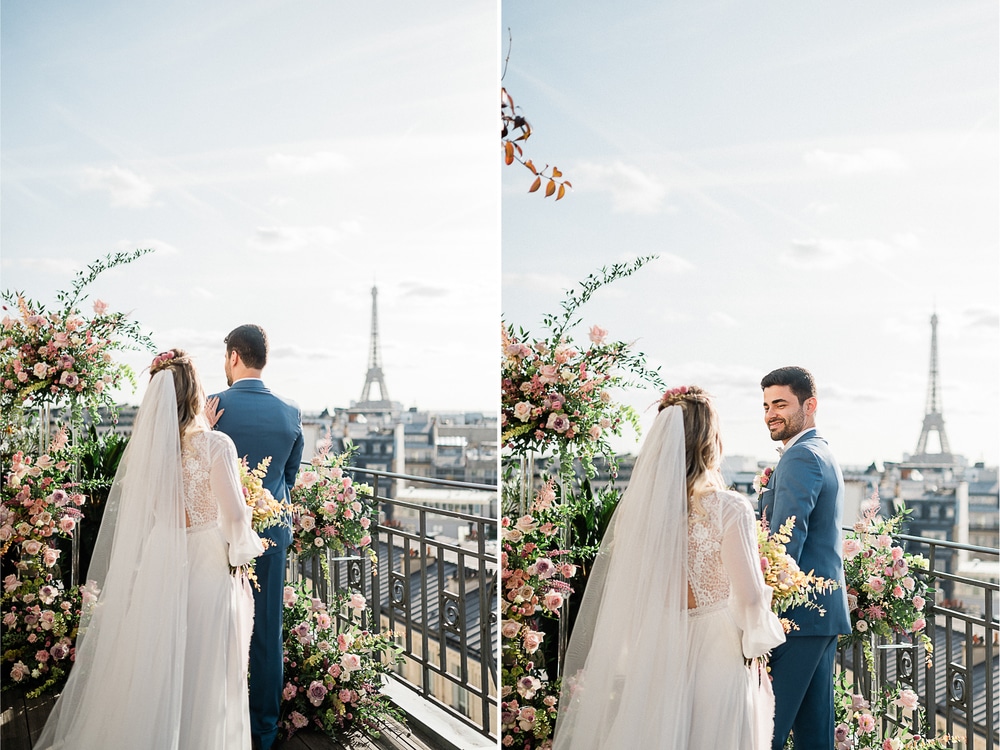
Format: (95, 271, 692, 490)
(215, 379, 304, 555)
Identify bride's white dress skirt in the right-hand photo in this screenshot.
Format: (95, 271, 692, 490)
(688, 601, 774, 750)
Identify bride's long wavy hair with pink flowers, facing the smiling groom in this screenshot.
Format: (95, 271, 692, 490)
(660, 385, 726, 516)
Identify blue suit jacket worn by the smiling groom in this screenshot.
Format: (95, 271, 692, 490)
(760, 430, 851, 636)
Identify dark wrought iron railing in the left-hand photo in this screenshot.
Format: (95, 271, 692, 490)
(290, 468, 499, 739)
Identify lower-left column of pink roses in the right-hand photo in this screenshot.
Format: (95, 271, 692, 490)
(500, 479, 578, 750)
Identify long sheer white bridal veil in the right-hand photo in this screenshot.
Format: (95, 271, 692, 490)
(553, 406, 690, 750)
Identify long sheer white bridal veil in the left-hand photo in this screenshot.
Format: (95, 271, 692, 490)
(35, 369, 188, 750)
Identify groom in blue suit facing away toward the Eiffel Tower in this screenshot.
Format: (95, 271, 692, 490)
(206, 325, 303, 750)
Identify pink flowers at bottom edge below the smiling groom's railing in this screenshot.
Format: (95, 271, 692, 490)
(834, 672, 956, 750)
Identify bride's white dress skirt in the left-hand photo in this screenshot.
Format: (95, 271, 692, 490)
(178, 522, 253, 750)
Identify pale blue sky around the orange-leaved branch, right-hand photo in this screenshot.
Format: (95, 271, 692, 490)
(501, 0, 1000, 466)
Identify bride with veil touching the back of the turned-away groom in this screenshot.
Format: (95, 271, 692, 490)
(35, 349, 263, 750)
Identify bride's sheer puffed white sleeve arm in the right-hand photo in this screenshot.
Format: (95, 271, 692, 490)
(722, 501, 785, 658)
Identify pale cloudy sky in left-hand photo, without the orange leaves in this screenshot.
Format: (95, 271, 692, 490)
(0, 0, 500, 413)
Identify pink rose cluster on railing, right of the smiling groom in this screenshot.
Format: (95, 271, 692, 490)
(841, 490, 933, 663)
